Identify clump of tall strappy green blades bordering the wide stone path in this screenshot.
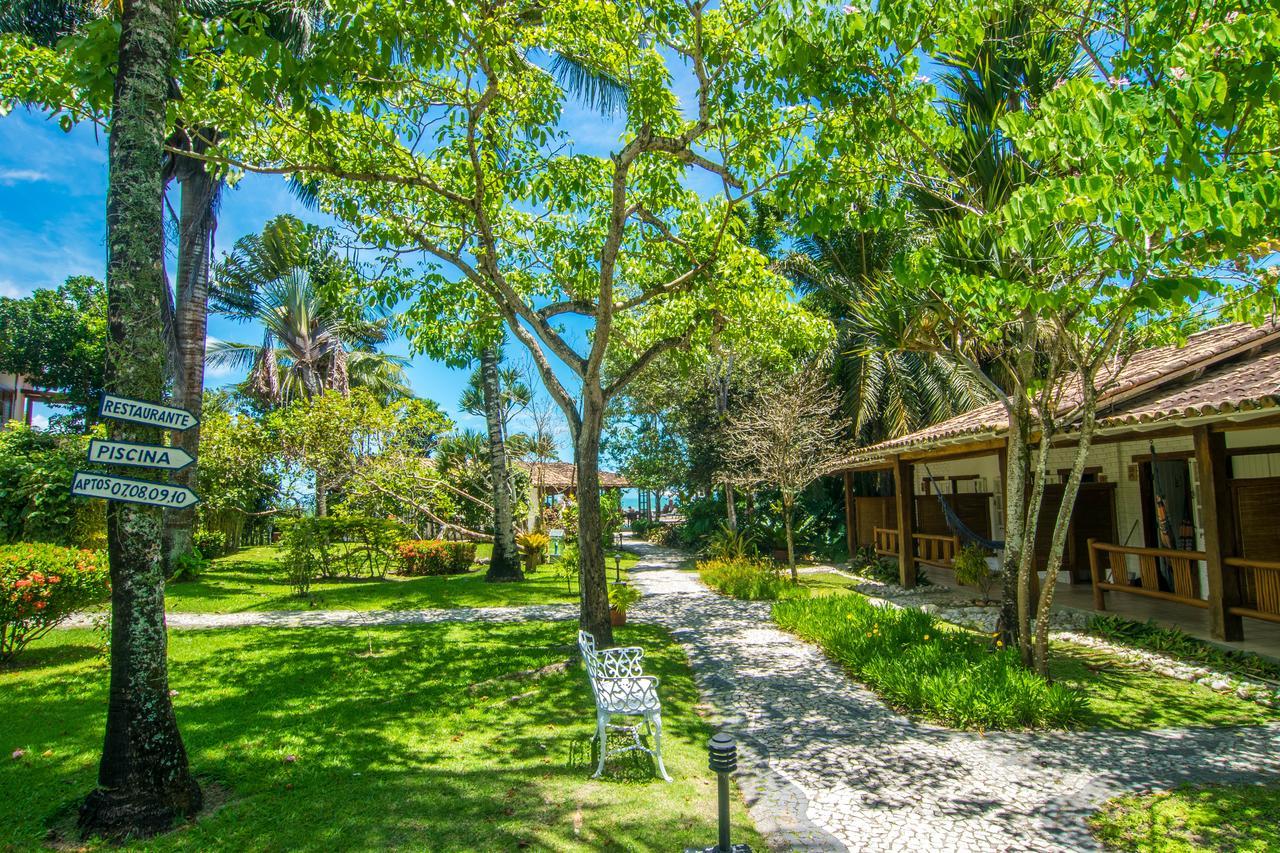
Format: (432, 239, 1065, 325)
(773, 596, 1085, 730)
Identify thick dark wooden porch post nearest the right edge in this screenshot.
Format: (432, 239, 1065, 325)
(1193, 427, 1244, 640)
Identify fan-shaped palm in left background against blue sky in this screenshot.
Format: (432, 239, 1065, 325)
(207, 216, 411, 406)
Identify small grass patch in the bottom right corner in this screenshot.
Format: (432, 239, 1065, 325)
(1089, 785, 1280, 853)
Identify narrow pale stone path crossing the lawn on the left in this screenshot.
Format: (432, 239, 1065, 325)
(63, 596, 577, 629)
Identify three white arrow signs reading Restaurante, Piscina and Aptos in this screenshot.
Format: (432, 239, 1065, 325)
(72, 394, 200, 510)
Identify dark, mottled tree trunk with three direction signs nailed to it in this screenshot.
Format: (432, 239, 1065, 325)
(79, 0, 201, 838)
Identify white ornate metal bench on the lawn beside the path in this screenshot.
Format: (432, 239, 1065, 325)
(577, 631, 671, 781)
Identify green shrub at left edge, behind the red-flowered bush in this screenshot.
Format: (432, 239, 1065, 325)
(0, 424, 106, 548)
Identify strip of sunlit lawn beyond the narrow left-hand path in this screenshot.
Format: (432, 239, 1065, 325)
(165, 546, 635, 613)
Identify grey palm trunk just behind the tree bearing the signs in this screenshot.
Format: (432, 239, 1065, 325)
(165, 142, 218, 566)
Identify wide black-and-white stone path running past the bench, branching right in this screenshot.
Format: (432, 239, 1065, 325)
(627, 542, 1280, 853)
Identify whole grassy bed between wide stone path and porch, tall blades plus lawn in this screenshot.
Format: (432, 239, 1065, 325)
(773, 593, 1280, 730)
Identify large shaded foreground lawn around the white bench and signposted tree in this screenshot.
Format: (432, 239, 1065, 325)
(0, 622, 764, 850)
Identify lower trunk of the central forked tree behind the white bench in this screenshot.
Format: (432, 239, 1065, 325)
(573, 384, 613, 647)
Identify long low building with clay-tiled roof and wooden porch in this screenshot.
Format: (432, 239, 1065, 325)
(832, 323, 1280, 639)
